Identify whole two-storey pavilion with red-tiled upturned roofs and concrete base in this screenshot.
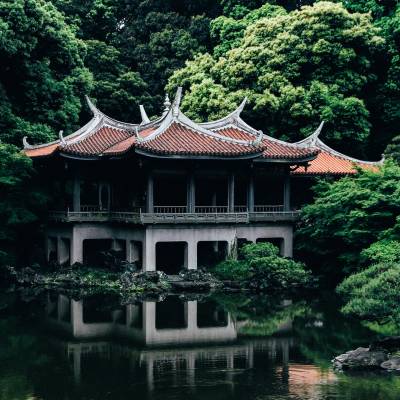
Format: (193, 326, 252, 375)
(24, 88, 377, 273)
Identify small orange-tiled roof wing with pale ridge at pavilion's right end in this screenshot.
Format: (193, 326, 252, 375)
(292, 123, 382, 175)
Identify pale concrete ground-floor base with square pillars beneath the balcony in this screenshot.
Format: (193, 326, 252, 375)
(46, 222, 293, 271)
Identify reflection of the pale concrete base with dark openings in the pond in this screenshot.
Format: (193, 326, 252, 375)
(47, 295, 237, 346)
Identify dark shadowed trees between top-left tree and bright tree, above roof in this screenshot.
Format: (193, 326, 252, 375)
(53, 0, 221, 120)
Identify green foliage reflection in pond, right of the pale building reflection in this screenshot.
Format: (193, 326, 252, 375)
(214, 294, 376, 367)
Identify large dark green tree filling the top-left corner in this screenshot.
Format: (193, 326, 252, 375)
(0, 0, 91, 144)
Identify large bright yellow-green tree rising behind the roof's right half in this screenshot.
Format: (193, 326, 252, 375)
(168, 2, 385, 153)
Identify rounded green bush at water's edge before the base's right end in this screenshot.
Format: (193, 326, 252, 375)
(214, 243, 312, 290)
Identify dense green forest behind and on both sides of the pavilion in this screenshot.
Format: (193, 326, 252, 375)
(0, 0, 400, 294)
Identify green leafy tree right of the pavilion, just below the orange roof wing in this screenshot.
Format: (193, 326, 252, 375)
(298, 161, 400, 275)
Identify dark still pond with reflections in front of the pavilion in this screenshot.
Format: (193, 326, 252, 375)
(0, 291, 400, 400)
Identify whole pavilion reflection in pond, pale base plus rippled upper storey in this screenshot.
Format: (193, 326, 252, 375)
(47, 295, 294, 390)
